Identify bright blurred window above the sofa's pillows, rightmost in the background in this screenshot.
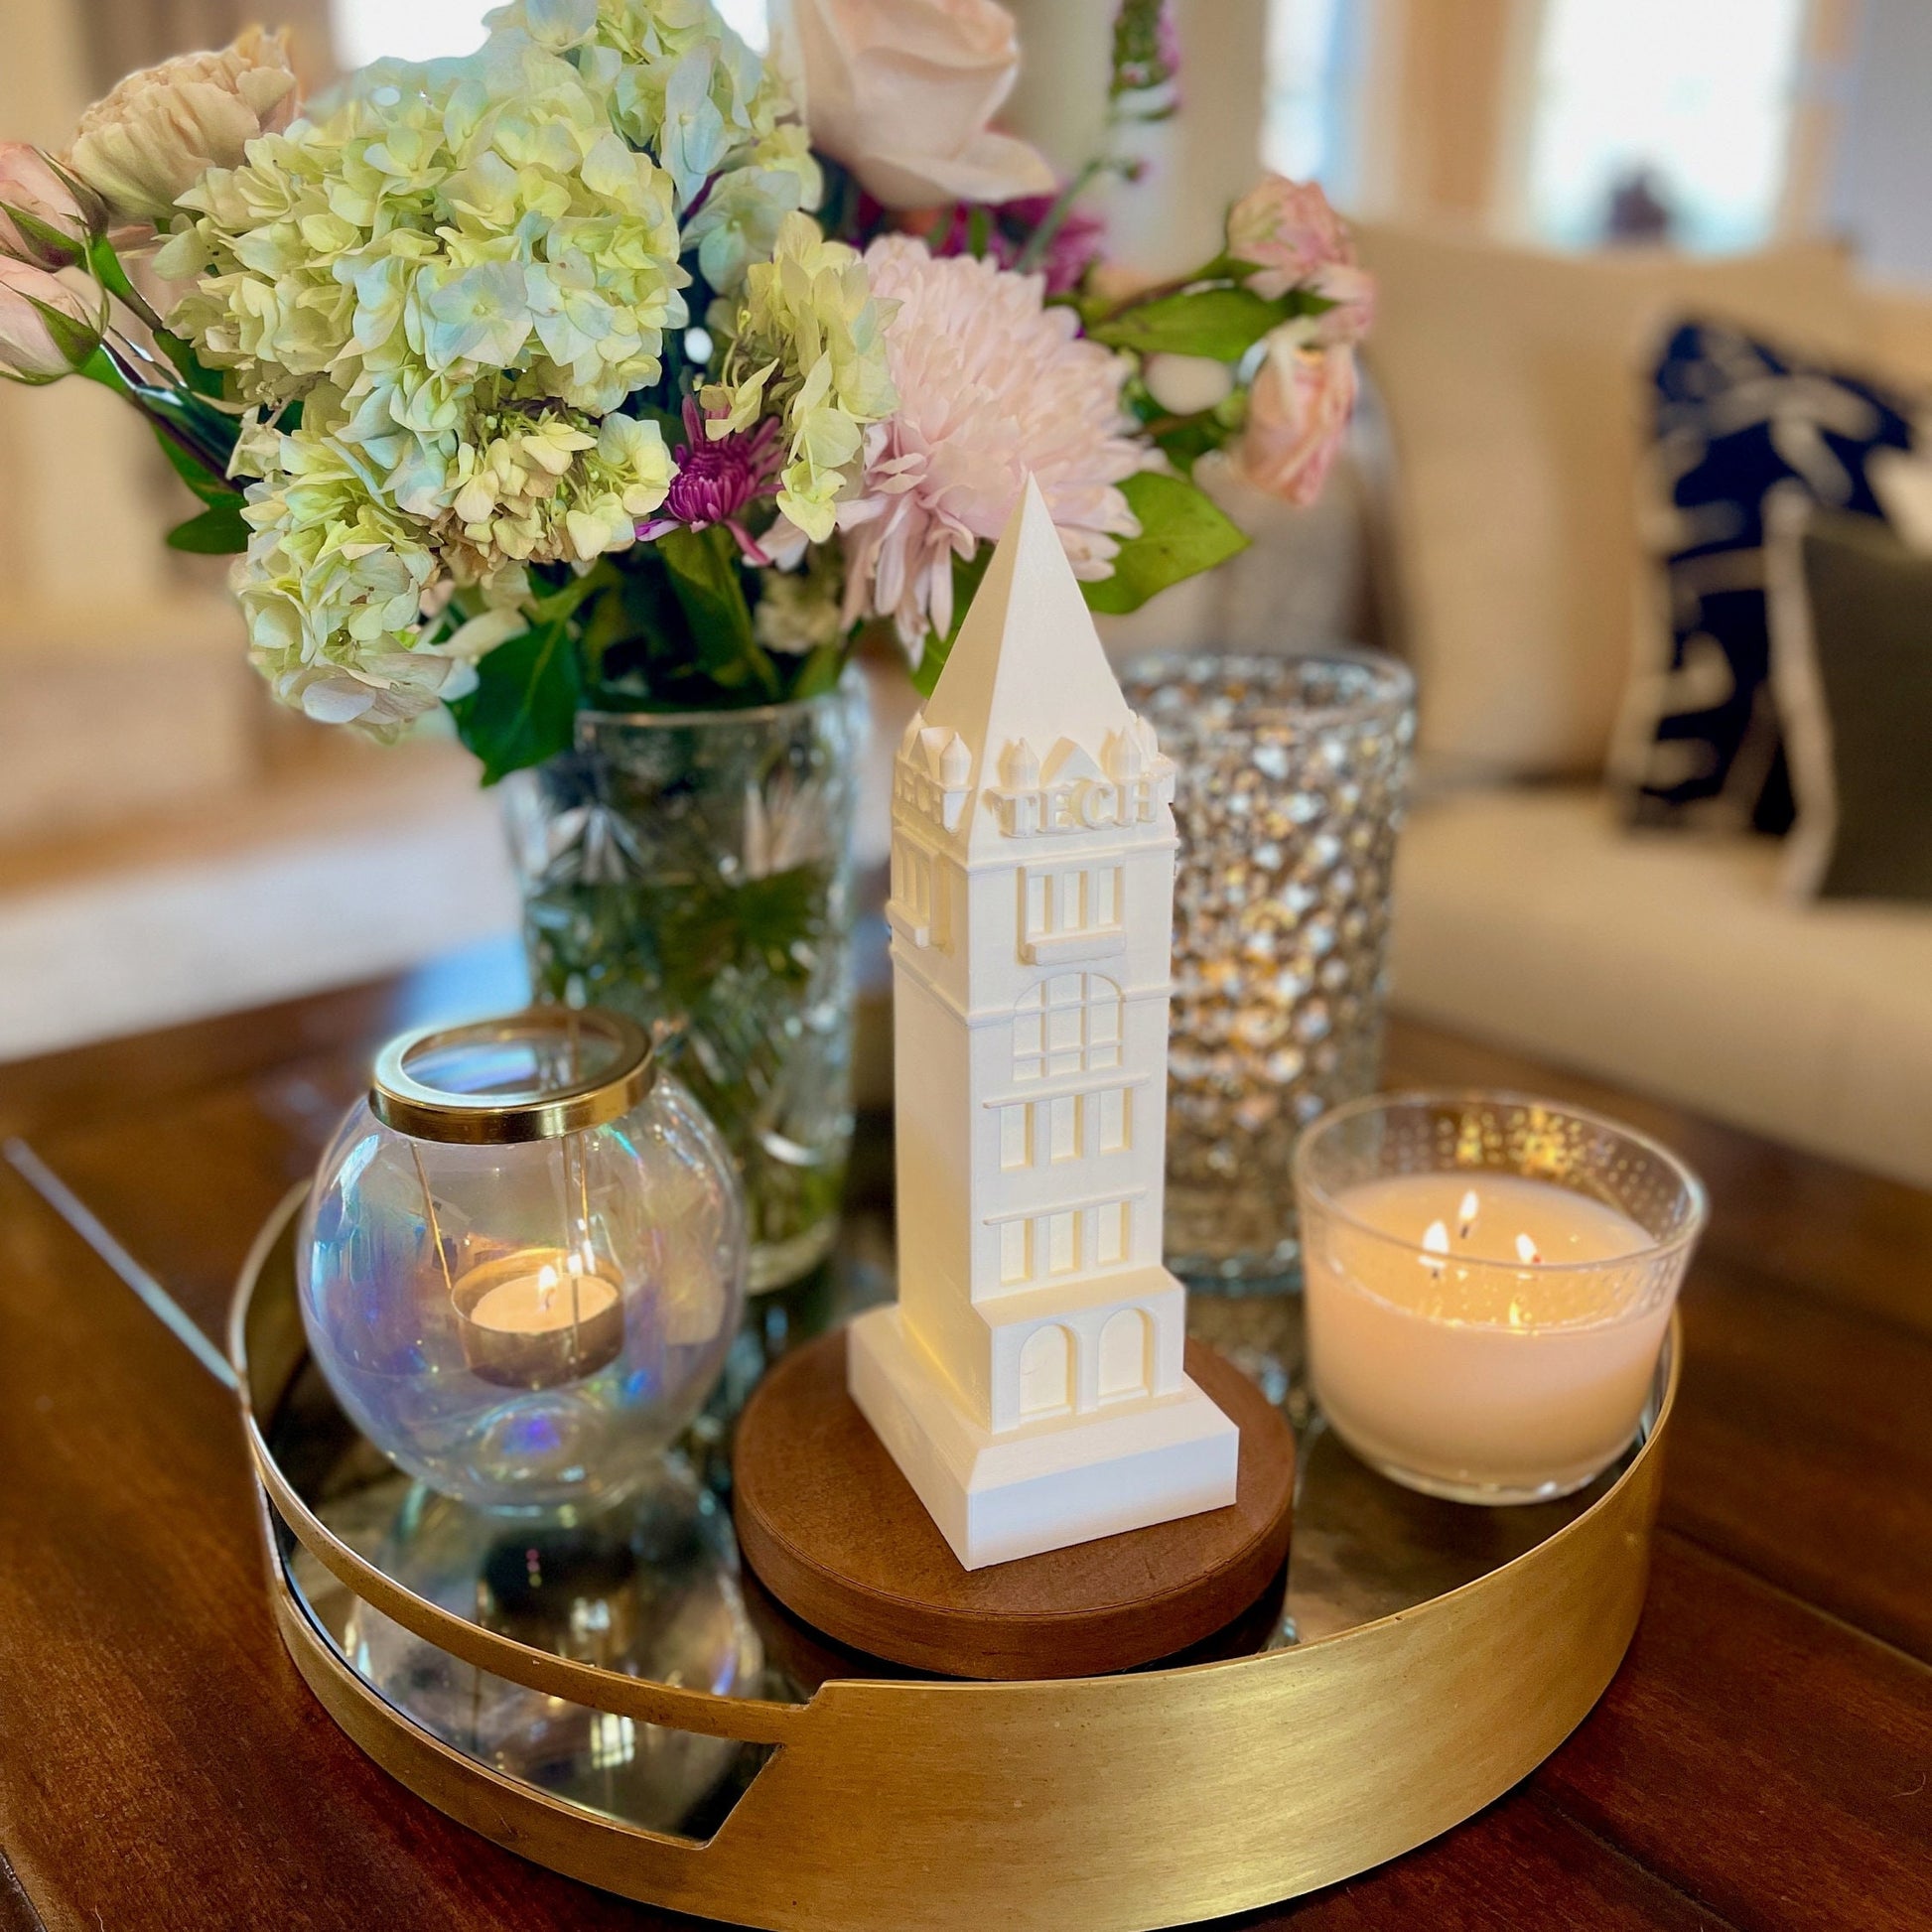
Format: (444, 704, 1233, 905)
(1522, 0, 1805, 253)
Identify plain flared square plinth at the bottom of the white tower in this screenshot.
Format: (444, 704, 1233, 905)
(846, 1305, 1240, 1571)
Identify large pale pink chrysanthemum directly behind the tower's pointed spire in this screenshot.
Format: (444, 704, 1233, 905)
(839, 235, 1148, 651)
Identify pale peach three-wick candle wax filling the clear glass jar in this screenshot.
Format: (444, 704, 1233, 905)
(1305, 1171, 1671, 1501)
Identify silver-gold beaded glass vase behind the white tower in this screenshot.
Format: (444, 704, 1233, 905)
(1125, 647, 1416, 1291)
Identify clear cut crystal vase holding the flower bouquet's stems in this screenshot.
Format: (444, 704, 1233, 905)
(504, 672, 866, 1291)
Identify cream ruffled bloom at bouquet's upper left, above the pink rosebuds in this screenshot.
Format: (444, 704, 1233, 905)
(68, 27, 298, 226)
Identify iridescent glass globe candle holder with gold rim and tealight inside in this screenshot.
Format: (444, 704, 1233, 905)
(296, 1007, 746, 1517)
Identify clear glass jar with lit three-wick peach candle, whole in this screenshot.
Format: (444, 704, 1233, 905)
(1295, 1093, 1704, 1503)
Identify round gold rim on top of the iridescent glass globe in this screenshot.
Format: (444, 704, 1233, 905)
(369, 1007, 657, 1146)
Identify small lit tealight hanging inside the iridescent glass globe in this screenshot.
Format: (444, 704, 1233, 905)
(450, 1250, 624, 1389)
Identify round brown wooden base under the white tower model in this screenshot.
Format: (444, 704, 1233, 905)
(733, 1333, 1295, 1677)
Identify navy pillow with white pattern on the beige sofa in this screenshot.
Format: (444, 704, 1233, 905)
(1617, 323, 1913, 833)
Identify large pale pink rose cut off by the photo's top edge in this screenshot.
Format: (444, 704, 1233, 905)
(784, 0, 1056, 208)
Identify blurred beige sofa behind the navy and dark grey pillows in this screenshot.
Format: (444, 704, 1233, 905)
(1364, 230, 1932, 1184)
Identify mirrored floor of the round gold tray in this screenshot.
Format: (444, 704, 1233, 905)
(274, 1301, 1664, 1840)
